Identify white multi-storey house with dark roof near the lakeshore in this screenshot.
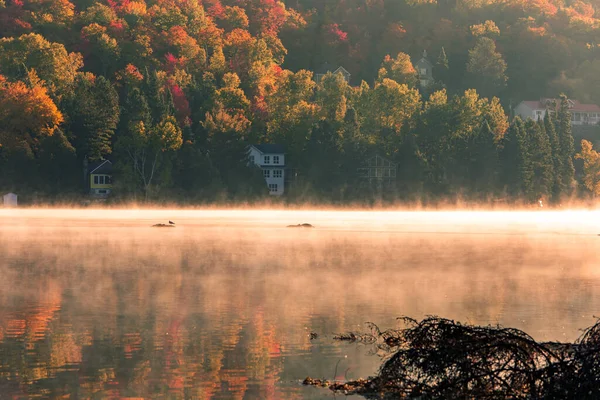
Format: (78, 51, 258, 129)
(248, 144, 285, 196)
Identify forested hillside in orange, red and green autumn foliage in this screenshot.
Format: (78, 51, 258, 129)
(0, 0, 600, 201)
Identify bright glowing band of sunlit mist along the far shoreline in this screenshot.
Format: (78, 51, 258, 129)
(0, 209, 600, 234)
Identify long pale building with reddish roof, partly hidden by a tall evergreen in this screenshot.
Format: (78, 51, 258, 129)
(514, 98, 600, 125)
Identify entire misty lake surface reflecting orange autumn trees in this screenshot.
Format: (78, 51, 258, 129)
(0, 210, 600, 399)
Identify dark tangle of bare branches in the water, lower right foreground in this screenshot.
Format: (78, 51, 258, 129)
(304, 317, 600, 399)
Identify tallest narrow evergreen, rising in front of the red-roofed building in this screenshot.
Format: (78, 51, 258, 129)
(556, 94, 575, 199)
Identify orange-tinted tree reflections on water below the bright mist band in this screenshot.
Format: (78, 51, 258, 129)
(0, 229, 600, 399)
